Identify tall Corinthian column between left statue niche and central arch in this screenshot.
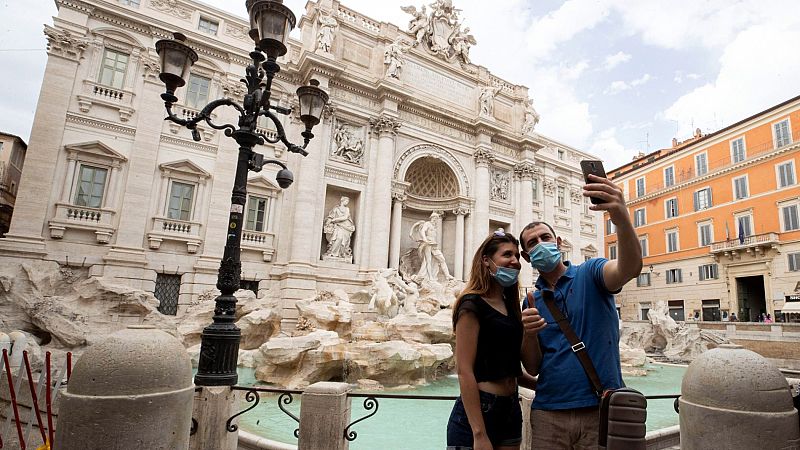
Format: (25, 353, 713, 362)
(369, 114, 400, 268)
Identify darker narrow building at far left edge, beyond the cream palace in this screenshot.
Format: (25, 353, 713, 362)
(0, 132, 28, 237)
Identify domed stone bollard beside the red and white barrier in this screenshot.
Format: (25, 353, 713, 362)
(53, 326, 194, 450)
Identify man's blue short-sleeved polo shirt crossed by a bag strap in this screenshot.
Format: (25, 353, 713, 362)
(522, 258, 623, 410)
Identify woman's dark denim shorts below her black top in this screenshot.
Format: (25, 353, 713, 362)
(447, 391, 522, 450)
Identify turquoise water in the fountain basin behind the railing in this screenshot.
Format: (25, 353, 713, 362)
(234, 364, 686, 450)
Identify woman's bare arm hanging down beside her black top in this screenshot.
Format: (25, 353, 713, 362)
(456, 312, 492, 450)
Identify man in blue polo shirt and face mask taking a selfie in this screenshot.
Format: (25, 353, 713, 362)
(520, 175, 642, 449)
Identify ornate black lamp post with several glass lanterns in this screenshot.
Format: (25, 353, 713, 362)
(156, 0, 328, 386)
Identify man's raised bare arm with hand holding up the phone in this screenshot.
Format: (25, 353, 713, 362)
(583, 175, 642, 292)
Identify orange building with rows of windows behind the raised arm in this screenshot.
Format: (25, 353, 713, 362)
(605, 96, 800, 321)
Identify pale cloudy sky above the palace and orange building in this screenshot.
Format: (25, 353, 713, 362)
(0, 0, 800, 169)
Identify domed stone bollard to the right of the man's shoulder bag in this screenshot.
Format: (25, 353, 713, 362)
(680, 344, 800, 450)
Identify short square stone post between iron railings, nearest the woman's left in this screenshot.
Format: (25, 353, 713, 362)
(297, 381, 351, 450)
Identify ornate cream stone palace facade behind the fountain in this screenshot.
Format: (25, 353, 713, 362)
(0, 0, 602, 318)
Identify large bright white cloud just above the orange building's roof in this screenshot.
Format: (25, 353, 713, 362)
(664, 19, 800, 139)
